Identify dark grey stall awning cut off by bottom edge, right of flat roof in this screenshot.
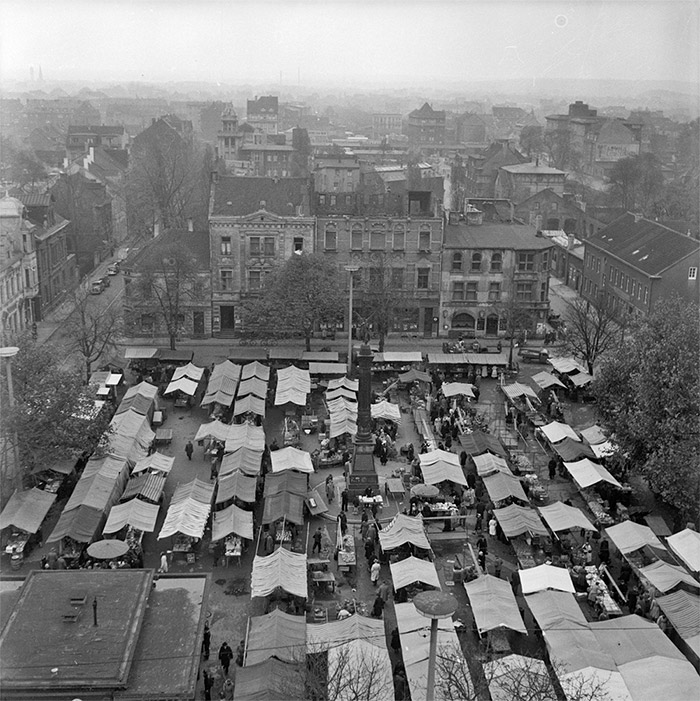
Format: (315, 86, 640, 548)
(233, 657, 306, 701)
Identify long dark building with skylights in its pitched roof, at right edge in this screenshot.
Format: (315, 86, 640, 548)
(582, 212, 700, 315)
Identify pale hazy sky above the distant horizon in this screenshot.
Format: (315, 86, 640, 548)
(0, 0, 700, 84)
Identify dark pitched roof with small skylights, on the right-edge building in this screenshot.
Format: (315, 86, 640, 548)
(586, 212, 700, 275)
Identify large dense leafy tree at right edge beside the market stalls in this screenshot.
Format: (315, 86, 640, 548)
(594, 297, 700, 519)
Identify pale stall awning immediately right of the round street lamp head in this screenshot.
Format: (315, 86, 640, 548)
(464, 574, 527, 635)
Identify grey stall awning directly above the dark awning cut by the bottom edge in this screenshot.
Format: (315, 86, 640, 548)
(245, 609, 306, 667)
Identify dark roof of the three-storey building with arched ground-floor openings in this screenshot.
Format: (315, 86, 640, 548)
(446, 222, 554, 250)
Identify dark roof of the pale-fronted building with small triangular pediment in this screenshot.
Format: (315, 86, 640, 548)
(211, 176, 308, 217)
